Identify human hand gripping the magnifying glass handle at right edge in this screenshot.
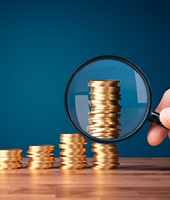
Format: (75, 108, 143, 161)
(147, 89, 170, 146)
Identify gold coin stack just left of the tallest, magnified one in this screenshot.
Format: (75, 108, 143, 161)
(59, 133, 87, 169)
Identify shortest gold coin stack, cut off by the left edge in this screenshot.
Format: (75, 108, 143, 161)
(0, 149, 22, 169)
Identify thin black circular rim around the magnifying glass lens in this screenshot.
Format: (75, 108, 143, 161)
(64, 55, 152, 144)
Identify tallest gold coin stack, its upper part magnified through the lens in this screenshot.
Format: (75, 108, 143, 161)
(87, 80, 121, 169)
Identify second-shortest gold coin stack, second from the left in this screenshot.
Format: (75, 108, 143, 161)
(27, 145, 55, 169)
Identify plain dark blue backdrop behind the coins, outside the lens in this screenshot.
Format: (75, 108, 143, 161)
(0, 0, 170, 157)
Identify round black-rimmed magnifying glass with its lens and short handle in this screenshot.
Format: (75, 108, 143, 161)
(64, 55, 163, 144)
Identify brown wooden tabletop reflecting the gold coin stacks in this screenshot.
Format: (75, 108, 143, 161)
(0, 158, 170, 200)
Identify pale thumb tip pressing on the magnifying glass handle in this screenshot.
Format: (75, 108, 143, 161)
(159, 107, 170, 129)
